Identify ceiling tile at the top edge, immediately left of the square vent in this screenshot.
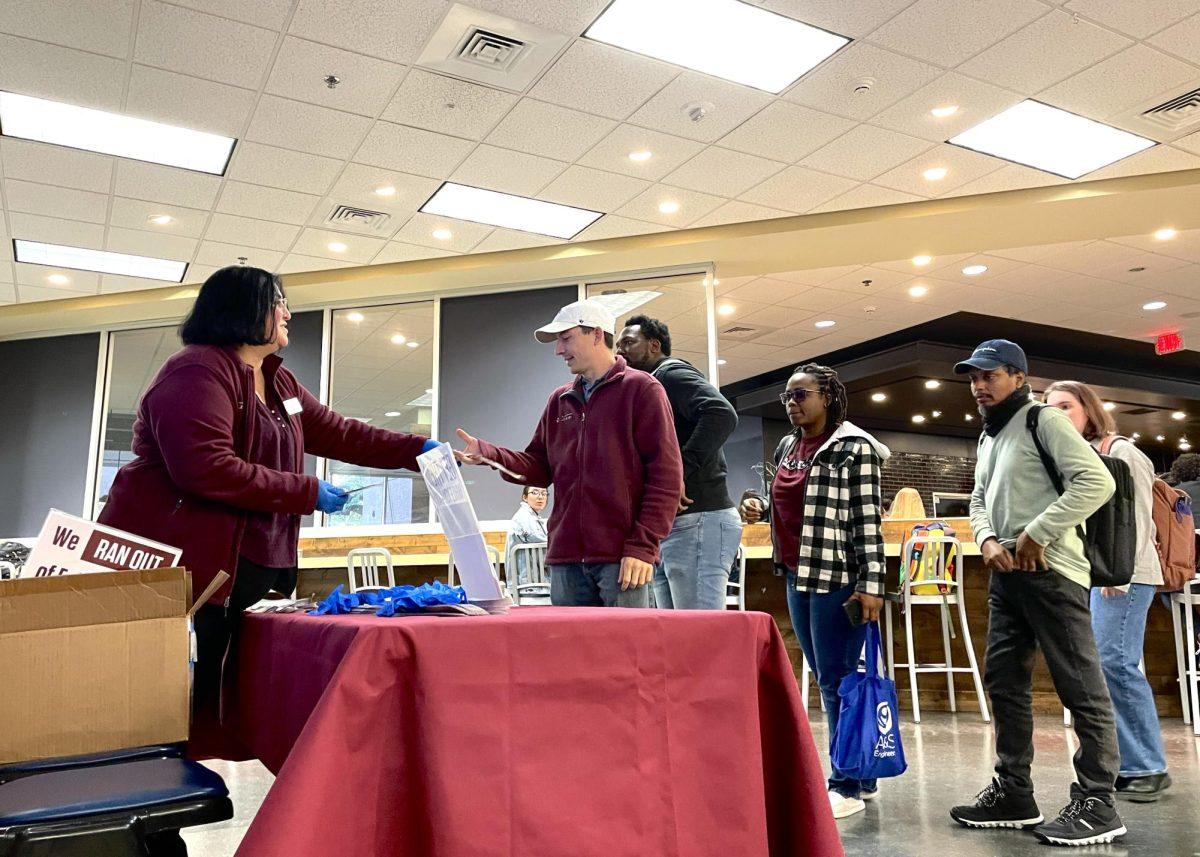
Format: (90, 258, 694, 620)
(289, 0, 450, 65)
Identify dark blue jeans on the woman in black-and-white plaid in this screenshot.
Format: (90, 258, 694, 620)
(787, 573, 875, 797)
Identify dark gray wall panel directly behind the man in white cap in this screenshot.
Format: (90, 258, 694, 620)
(437, 286, 578, 520)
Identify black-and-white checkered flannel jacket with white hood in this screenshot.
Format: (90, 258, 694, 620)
(748, 422, 892, 597)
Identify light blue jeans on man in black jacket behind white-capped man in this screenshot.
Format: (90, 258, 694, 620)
(654, 509, 742, 610)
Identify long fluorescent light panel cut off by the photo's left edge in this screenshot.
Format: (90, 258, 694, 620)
(0, 92, 236, 175)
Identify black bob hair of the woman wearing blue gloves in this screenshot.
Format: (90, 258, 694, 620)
(179, 265, 286, 346)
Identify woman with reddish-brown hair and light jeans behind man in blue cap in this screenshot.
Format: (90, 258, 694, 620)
(1045, 380, 1171, 803)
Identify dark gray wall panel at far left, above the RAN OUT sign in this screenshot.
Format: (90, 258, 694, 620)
(0, 334, 100, 537)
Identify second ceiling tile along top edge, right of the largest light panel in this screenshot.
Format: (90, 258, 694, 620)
(871, 0, 1048, 68)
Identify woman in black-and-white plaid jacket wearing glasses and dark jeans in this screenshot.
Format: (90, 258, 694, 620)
(740, 364, 890, 819)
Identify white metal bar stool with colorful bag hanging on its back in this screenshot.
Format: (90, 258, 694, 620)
(883, 535, 991, 723)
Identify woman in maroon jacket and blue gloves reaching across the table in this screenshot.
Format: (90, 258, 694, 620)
(98, 268, 434, 753)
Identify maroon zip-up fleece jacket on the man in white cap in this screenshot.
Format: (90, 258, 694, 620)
(479, 356, 683, 563)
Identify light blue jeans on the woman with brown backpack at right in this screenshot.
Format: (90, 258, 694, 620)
(1092, 583, 1166, 777)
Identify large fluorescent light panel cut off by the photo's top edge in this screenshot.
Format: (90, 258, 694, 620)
(583, 0, 850, 94)
